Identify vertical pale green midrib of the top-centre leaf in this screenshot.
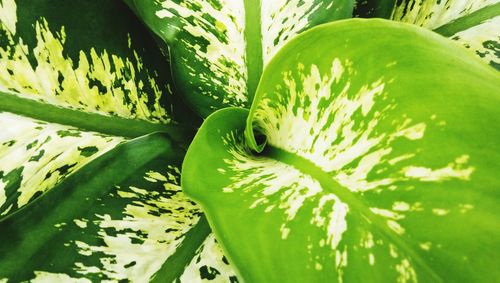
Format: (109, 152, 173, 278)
(245, 0, 263, 105)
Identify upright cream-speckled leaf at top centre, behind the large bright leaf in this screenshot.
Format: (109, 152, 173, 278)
(125, 0, 354, 116)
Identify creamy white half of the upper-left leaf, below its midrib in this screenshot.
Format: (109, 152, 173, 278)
(0, 112, 125, 216)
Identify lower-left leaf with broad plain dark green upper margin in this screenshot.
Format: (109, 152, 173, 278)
(0, 134, 236, 282)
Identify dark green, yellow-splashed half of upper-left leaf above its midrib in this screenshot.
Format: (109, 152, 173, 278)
(0, 0, 198, 124)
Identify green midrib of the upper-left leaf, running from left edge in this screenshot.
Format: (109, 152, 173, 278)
(0, 91, 194, 143)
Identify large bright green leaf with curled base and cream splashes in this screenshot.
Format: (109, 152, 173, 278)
(182, 20, 500, 282)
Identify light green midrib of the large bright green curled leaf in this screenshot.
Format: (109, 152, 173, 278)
(262, 144, 444, 282)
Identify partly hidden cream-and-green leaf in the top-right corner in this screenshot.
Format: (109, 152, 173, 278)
(357, 0, 500, 70)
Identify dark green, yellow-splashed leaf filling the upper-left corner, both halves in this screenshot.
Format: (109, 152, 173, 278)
(0, 0, 195, 219)
